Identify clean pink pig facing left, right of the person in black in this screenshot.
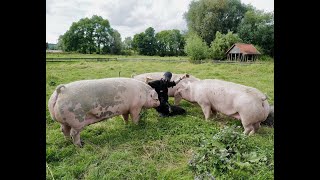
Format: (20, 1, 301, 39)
(175, 79, 269, 135)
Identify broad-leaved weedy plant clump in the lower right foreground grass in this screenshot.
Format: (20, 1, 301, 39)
(189, 125, 268, 179)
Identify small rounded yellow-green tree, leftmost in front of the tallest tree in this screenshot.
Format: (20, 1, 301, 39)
(184, 33, 208, 63)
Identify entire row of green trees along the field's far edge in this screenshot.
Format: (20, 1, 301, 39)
(54, 0, 274, 60)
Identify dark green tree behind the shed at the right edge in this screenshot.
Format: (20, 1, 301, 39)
(238, 9, 274, 57)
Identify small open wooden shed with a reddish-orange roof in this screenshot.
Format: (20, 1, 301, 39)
(226, 43, 261, 61)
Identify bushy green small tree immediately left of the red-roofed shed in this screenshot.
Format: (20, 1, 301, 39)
(210, 31, 242, 59)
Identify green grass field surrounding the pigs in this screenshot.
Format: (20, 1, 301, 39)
(46, 55, 274, 180)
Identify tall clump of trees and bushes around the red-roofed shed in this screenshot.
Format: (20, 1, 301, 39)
(184, 0, 274, 61)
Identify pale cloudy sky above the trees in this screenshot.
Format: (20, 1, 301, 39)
(46, 0, 274, 43)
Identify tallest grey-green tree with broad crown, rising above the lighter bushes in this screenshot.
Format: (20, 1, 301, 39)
(184, 0, 248, 45)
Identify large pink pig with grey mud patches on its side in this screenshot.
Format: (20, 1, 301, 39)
(48, 78, 160, 147)
